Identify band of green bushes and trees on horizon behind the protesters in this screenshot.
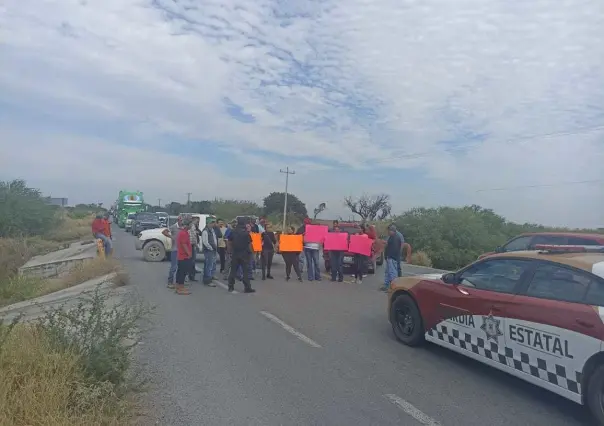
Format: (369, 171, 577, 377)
(148, 192, 604, 270)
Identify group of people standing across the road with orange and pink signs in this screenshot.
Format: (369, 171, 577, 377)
(163, 214, 404, 294)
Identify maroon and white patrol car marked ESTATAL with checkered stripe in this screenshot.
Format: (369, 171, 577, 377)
(388, 245, 604, 425)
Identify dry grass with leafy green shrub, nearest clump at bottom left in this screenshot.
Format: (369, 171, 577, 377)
(0, 288, 149, 426)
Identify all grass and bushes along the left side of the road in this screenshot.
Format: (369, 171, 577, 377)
(0, 181, 149, 426)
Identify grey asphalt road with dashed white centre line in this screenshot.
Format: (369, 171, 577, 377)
(115, 231, 589, 426)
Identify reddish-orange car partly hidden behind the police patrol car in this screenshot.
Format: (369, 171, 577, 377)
(478, 232, 604, 259)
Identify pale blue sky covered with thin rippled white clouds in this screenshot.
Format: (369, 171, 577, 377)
(0, 0, 604, 227)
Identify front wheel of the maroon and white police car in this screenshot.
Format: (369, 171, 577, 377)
(390, 294, 424, 346)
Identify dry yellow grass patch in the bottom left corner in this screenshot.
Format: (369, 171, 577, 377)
(0, 325, 128, 426)
